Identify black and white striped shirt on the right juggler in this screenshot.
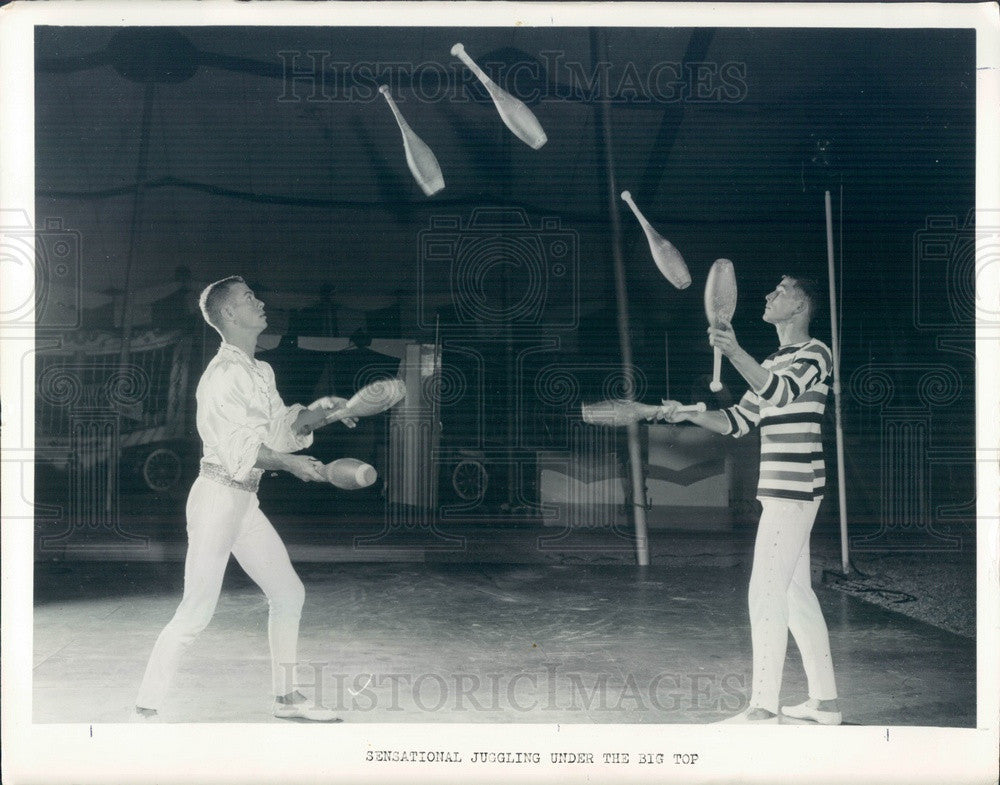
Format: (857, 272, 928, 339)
(722, 338, 833, 501)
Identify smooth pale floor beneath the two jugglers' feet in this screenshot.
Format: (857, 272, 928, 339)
(33, 556, 976, 727)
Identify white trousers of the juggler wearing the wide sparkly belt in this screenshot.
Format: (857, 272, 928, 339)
(136, 477, 305, 709)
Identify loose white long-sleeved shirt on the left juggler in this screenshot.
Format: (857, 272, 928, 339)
(196, 341, 313, 482)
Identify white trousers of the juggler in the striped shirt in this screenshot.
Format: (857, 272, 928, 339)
(749, 499, 837, 713)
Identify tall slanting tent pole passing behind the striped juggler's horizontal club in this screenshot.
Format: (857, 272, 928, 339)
(590, 30, 649, 567)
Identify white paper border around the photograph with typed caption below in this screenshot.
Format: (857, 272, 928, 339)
(0, 0, 1000, 785)
